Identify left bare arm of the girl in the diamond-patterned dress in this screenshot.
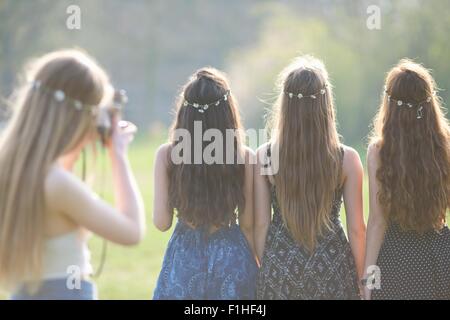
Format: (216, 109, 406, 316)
(253, 145, 271, 261)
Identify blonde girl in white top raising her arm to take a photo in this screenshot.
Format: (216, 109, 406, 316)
(0, 50, 145, 299)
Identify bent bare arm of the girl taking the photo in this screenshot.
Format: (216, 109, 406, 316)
(45, 125, 145, 245)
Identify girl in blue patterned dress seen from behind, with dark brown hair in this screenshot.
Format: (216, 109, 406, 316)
(154, 69, 257, 299)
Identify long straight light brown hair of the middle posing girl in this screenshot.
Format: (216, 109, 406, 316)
(269, 56, 341, 251)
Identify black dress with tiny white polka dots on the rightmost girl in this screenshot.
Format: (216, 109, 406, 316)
(372, 224, 450, 300)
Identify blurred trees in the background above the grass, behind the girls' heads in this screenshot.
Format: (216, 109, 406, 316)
(0, 0, 450, 147)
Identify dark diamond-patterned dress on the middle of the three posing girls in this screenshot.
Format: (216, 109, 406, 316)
(257, 148, 359, 300)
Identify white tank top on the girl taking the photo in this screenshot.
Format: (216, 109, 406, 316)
(42, 230, 93, 279)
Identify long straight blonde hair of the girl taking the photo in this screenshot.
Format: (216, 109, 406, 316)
(0, 50, 109, 289)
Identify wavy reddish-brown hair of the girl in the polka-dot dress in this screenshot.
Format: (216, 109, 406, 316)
(372, 59, 450, 233)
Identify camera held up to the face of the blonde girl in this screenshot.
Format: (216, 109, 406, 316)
(97, 90, 128, 145)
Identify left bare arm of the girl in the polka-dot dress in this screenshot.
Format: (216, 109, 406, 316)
(363, 145, 386, 299)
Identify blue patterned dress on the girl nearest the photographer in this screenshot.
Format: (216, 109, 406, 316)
(153, 220, 258, 300)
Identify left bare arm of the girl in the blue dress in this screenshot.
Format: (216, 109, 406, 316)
(153, 144, 173, 231)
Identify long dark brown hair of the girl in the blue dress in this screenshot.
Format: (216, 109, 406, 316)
(169, 68, 245, 227)
